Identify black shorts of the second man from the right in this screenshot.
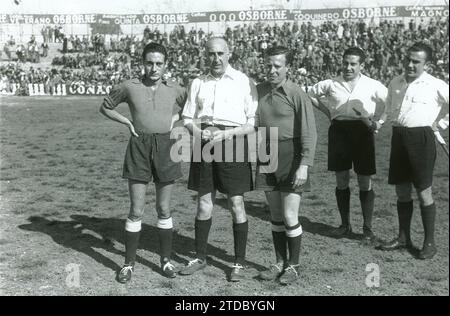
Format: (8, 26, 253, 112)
(328, 120, 376, 176)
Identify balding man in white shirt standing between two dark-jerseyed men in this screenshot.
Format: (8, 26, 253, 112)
(180, 38, 258, 282)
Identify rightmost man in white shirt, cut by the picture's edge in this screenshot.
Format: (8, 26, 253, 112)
(380, 43, 449, 259)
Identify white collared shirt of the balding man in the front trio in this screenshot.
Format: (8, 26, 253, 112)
(183, 65, 258, 126)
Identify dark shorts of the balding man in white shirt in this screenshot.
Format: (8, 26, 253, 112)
(188, 126, 253, 195)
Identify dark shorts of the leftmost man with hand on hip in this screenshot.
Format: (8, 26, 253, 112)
(122, 131, 182, 183)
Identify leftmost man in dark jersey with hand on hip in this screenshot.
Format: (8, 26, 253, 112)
(100, 43, 187, 283)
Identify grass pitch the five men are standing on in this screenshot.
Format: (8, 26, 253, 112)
(0, 97, 449, 296)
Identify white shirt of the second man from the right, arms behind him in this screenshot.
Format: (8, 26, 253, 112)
(308, 74, 387, 120)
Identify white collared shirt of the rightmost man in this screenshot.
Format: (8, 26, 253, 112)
(386, 72, 449, 127)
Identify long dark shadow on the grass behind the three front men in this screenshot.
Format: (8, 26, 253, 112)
(19, 215, 264, 273)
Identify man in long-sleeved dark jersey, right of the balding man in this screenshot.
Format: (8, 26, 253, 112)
(255, 46, 317, 285)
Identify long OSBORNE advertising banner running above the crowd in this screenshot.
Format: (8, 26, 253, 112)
(0, 6, 449, 25)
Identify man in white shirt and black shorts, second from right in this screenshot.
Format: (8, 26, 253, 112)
(308, 47, 387, 245)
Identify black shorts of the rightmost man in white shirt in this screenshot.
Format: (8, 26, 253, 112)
(388, 127, 436, 190)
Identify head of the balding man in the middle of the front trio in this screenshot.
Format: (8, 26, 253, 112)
(206, 37, 229, 78)
